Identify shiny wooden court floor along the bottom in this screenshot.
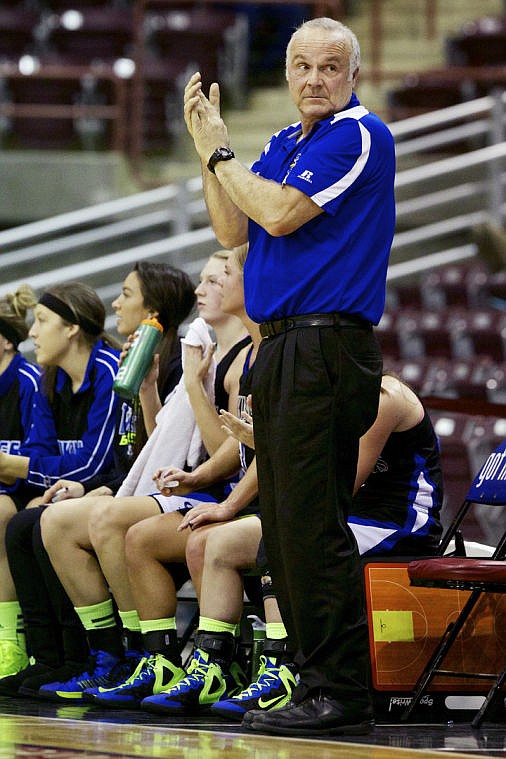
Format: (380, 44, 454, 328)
(0, 698, 506, 759)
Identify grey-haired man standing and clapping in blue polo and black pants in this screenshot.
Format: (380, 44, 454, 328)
(185, 18, 395, 735)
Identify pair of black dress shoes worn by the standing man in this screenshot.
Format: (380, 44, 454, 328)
(242, 695, 374, 735)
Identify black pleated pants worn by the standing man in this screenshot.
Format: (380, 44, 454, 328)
(253, 325, 382, 705)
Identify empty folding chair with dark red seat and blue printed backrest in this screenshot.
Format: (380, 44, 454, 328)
(401, 441, 506, 727)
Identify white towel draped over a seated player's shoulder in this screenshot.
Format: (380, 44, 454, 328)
(116, 317, 216, 496)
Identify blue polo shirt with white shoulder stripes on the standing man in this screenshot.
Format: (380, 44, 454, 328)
(244, 94, 395, 324)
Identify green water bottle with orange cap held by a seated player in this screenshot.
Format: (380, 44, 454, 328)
(113, 318, 163, 399)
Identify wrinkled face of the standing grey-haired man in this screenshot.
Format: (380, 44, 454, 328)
(286, 29, 358, 134)
